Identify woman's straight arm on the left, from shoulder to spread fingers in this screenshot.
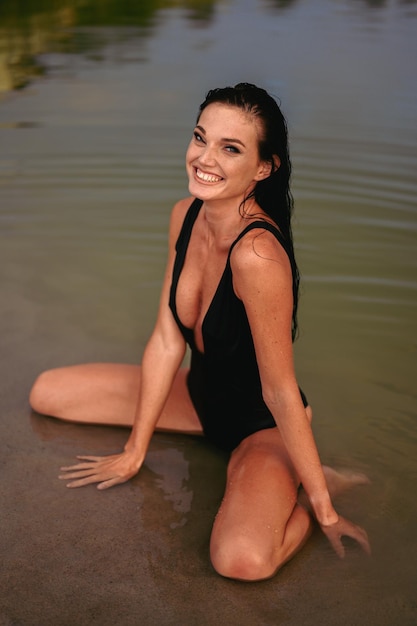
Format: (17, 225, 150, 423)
(60, 198, 190, 489)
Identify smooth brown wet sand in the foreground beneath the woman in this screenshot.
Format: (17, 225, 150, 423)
(0, 294, 416, 626)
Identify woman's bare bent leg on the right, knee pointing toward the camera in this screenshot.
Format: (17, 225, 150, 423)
(210, 428, 312, 581)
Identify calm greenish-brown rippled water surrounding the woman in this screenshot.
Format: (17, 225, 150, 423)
(0, 0, 417, 624)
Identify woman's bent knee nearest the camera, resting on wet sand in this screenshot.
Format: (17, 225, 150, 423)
(210, 537, 277, 582)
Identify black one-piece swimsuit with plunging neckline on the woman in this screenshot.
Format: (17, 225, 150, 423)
(169, 199, 307, 451)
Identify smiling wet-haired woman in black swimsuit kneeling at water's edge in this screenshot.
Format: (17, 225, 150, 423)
(31, 84, 369, 580)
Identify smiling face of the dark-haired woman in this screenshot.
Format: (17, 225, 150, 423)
(186, 103, 271, 204)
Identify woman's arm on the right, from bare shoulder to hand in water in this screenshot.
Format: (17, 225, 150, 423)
(231, 231, 369, 556)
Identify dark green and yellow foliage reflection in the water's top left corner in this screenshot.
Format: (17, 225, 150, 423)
(0, 0, 216, 92)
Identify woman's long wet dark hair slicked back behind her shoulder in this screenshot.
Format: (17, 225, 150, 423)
(197, 83, 300, 340)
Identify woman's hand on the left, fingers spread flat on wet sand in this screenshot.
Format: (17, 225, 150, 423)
(59, 451, 142, 489)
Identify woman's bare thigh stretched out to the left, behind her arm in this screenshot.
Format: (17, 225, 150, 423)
(30, 363, 202, 434)
